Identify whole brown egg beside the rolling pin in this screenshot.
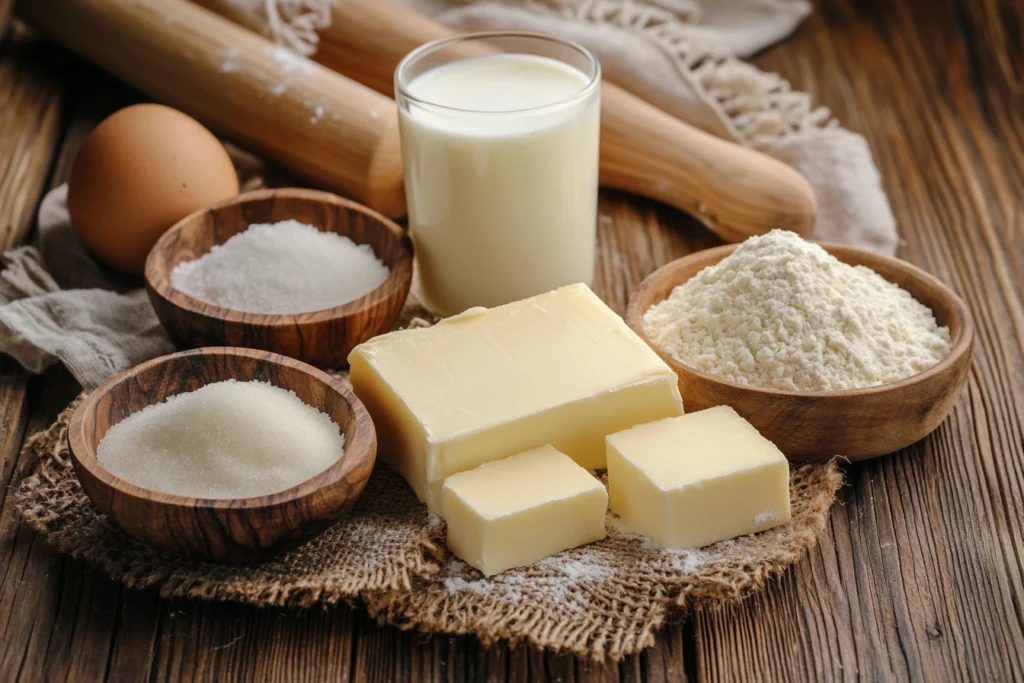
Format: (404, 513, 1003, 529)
(68, 104, 239, 274)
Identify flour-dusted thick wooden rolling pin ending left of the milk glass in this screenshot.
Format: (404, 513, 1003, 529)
(15, 0, 406, 217)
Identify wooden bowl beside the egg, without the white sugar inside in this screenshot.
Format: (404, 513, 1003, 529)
(145, 188, 413, 368)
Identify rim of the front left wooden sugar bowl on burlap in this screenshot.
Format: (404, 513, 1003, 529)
(68, 346, 376, 511)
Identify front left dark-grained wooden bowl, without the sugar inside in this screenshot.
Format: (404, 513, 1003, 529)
(68, 348, 377, 563)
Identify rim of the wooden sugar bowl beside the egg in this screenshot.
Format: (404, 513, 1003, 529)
(144, 187, 414, 328)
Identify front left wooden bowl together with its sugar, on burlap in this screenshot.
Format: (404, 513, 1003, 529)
(68, 348, 377, 563)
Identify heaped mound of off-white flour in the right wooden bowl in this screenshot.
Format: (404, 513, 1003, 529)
(643, 230, 950, 391)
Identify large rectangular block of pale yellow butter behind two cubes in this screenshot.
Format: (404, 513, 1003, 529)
(348, 285, 683, 512)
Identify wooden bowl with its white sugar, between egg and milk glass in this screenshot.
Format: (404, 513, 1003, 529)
(145, 188, 413, 368)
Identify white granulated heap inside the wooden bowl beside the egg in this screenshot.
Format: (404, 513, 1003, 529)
(171, 220, 388, 314)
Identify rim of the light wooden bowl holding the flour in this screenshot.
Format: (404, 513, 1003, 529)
(626, 241, 975, 398)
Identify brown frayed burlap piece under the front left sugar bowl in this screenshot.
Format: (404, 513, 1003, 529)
(13, 394, 442, 607)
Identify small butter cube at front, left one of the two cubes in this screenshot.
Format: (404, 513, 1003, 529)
(441, 445, 608, 577)
